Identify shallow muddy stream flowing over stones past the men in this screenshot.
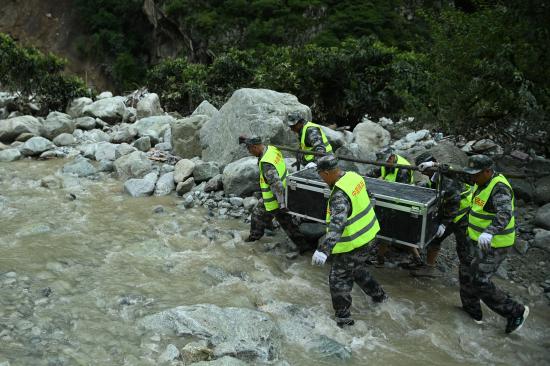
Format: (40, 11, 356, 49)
(0, 160, 550, 366)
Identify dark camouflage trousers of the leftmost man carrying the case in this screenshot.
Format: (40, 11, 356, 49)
(250, 199, 316, 252)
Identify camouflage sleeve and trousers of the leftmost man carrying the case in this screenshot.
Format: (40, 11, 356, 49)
(250, 150, 312, 252)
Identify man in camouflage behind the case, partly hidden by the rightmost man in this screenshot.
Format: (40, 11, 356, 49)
(411, 152, 473, 277)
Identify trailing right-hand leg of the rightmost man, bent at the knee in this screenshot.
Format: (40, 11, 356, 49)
(472, 247, 524, 318)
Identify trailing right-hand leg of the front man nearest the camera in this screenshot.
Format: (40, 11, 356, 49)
(356, 243, 387, 302)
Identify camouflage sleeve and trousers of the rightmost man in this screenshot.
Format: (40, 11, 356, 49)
(457, 174, 524, 320)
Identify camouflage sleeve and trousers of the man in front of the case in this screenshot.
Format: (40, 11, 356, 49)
(318, 181, 386, 324)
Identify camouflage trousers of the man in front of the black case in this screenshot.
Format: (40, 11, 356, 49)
(329, 239, 385, 323)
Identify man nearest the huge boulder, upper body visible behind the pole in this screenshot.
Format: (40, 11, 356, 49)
(287, 112, 332, 169)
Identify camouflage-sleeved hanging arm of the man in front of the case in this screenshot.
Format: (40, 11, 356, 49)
(318, 188, 351, 255)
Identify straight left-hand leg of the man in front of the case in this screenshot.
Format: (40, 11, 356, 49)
(329, 253, 353, 326)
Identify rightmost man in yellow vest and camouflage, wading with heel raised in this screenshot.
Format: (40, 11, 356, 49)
(457, 155, 529, 333)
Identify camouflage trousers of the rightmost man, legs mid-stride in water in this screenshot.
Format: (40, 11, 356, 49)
(457, 238, 524, 320)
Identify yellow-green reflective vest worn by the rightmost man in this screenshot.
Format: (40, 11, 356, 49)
(468, 174, 516, 248)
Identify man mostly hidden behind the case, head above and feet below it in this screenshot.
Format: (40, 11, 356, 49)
(367, 146, 424, 269)
